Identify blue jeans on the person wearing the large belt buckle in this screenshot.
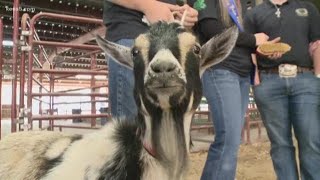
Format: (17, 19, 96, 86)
(254, 72, 320, 180)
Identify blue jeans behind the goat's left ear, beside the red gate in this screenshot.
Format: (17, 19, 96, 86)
(108, 39, 137, 119)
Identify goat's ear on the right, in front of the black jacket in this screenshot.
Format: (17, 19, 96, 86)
(200, 27, 239, 75)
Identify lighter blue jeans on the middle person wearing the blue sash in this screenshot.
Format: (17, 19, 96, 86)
(201, 69, 250, 180)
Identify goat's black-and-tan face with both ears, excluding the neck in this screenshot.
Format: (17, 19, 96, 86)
(97, 22, 238, 112)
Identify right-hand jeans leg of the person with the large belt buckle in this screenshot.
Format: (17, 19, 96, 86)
(290, 73, 320, 180)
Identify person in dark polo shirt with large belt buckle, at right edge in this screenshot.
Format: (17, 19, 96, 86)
(245, 0, 320, 180)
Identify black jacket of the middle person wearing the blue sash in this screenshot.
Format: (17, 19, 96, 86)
(195, 0, 256, 76)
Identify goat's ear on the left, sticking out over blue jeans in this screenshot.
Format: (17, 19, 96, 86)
(96, 36, 133, 69)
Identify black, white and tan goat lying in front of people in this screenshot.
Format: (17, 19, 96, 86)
(0, 22, 238, 180)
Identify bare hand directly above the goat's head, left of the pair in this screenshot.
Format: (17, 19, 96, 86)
(142, 1, 179, 24)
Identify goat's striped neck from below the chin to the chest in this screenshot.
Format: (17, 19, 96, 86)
(138, 93, 194, 179)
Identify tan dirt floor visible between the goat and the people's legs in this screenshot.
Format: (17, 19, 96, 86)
(187, 142, 276, 180)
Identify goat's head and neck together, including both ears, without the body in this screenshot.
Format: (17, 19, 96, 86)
(97, 22, 238, 172)
